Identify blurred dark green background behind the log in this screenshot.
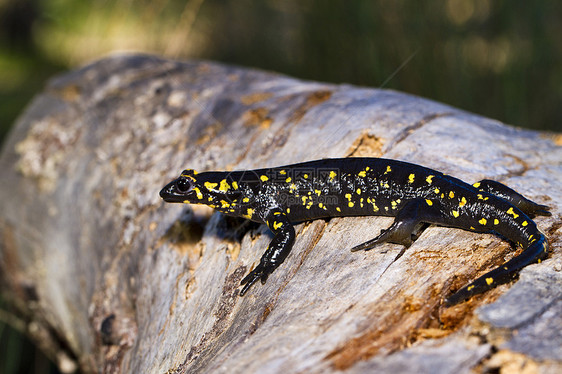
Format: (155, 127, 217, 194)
(0, 0, 562, 373)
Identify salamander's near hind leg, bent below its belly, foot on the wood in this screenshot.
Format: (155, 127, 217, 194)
(351, 198, 442, 252)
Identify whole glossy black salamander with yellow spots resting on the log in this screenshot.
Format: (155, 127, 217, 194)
(160, 158, 550, 306)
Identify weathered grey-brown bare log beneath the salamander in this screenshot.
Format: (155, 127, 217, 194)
(0, 56, 562, 373)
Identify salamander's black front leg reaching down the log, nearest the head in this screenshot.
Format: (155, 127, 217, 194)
(240, 210, 295, 296)
